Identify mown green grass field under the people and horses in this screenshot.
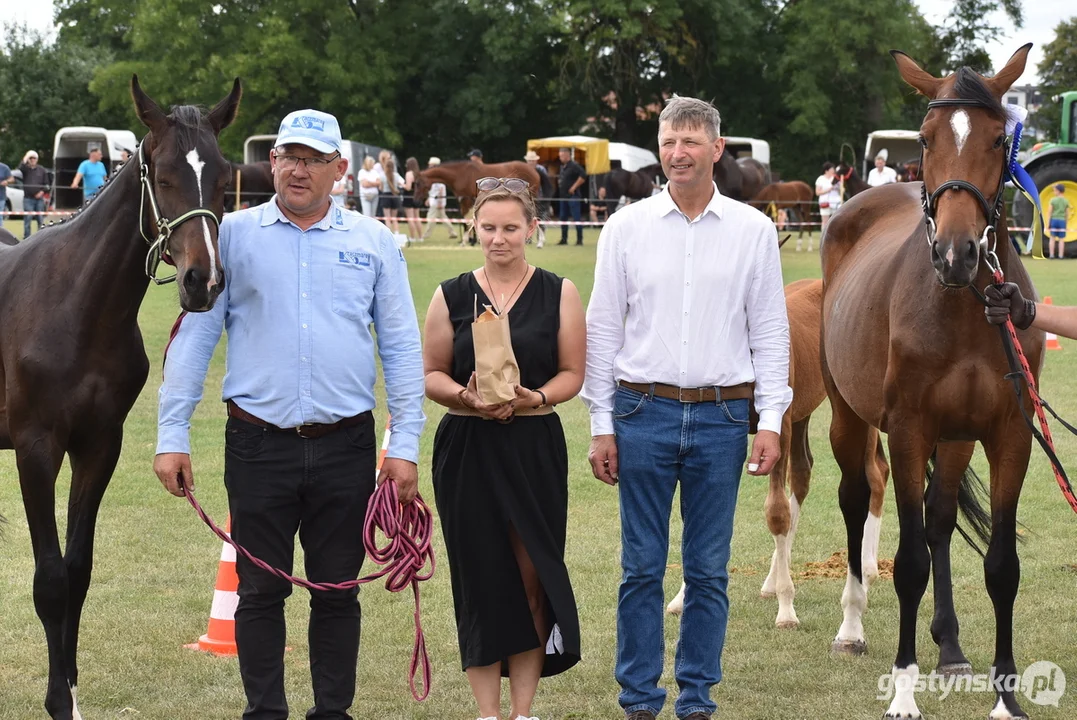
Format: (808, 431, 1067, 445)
(0, 223, 1077, 720)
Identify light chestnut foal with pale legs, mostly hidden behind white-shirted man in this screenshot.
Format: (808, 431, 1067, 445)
(666, 280, 890, 629)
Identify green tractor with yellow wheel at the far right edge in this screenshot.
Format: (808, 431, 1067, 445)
(1013, 90, 1077, 257)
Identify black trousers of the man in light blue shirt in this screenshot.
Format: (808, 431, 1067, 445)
(224, 413, 376, 720)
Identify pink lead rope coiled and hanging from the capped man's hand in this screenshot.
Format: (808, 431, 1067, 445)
(183, 480, 434, 702)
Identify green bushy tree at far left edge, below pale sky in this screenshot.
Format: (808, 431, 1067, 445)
(0, 26, 127, 165)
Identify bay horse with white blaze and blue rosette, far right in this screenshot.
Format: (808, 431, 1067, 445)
(822, 45, 1044, 720)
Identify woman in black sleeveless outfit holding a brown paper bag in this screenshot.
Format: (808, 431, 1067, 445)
(423, 179, 587, 720)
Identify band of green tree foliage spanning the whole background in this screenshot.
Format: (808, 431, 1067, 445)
(0, 0, 1021, 185)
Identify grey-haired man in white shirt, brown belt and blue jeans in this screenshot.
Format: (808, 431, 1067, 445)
(582, 97, 793, 720)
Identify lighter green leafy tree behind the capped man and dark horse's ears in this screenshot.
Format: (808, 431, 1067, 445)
(68, 0, 400, 157)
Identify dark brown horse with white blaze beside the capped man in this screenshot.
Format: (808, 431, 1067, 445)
(0, 77, 240, 720)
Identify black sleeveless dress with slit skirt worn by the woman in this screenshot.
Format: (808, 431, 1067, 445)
(433, 268, 579, 676)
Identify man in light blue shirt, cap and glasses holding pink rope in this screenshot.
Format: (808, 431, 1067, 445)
(154, 110, 425, 720)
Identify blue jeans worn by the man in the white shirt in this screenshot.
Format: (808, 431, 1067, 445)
(614, 386, 749, 718)
